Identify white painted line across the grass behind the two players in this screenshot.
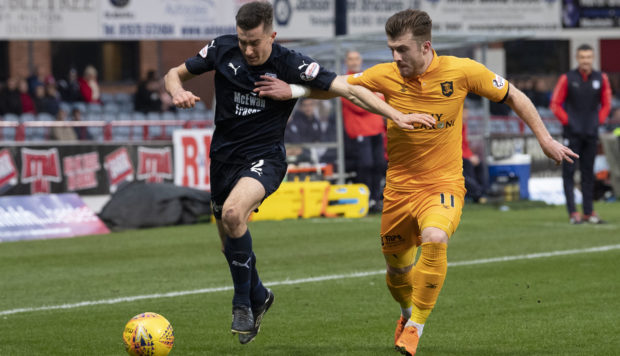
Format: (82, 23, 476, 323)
(0, 244, 620, 316)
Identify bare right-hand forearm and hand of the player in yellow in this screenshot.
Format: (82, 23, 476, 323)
(506, 84, 579, 164)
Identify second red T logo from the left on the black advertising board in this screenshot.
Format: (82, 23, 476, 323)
(21, 148, 62, 194)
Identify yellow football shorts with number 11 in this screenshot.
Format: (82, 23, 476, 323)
(381, 185, 465, 254)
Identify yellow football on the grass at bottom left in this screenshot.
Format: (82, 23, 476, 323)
(123, 313, 174, 356)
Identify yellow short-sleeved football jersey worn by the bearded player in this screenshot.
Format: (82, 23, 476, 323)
(348, 51, 508, 191)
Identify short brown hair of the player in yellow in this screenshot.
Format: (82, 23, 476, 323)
(385, 9, 433, 42)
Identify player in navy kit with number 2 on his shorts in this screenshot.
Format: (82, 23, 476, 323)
(165, 2, 435, 344)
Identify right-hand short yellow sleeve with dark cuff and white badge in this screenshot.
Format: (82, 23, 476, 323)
(462, 59, 509, 103)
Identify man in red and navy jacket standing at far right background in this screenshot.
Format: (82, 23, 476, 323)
(550, 44, 611, 224)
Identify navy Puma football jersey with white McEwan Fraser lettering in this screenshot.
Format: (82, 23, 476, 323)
(185, 35, 336, 162)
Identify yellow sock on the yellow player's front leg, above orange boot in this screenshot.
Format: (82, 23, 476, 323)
(412, 242, 448, 325)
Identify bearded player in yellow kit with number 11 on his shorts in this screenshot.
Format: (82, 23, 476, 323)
(257, 9, 578, 355)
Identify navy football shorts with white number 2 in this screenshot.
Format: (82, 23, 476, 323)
(210, 159, 288, 219)
